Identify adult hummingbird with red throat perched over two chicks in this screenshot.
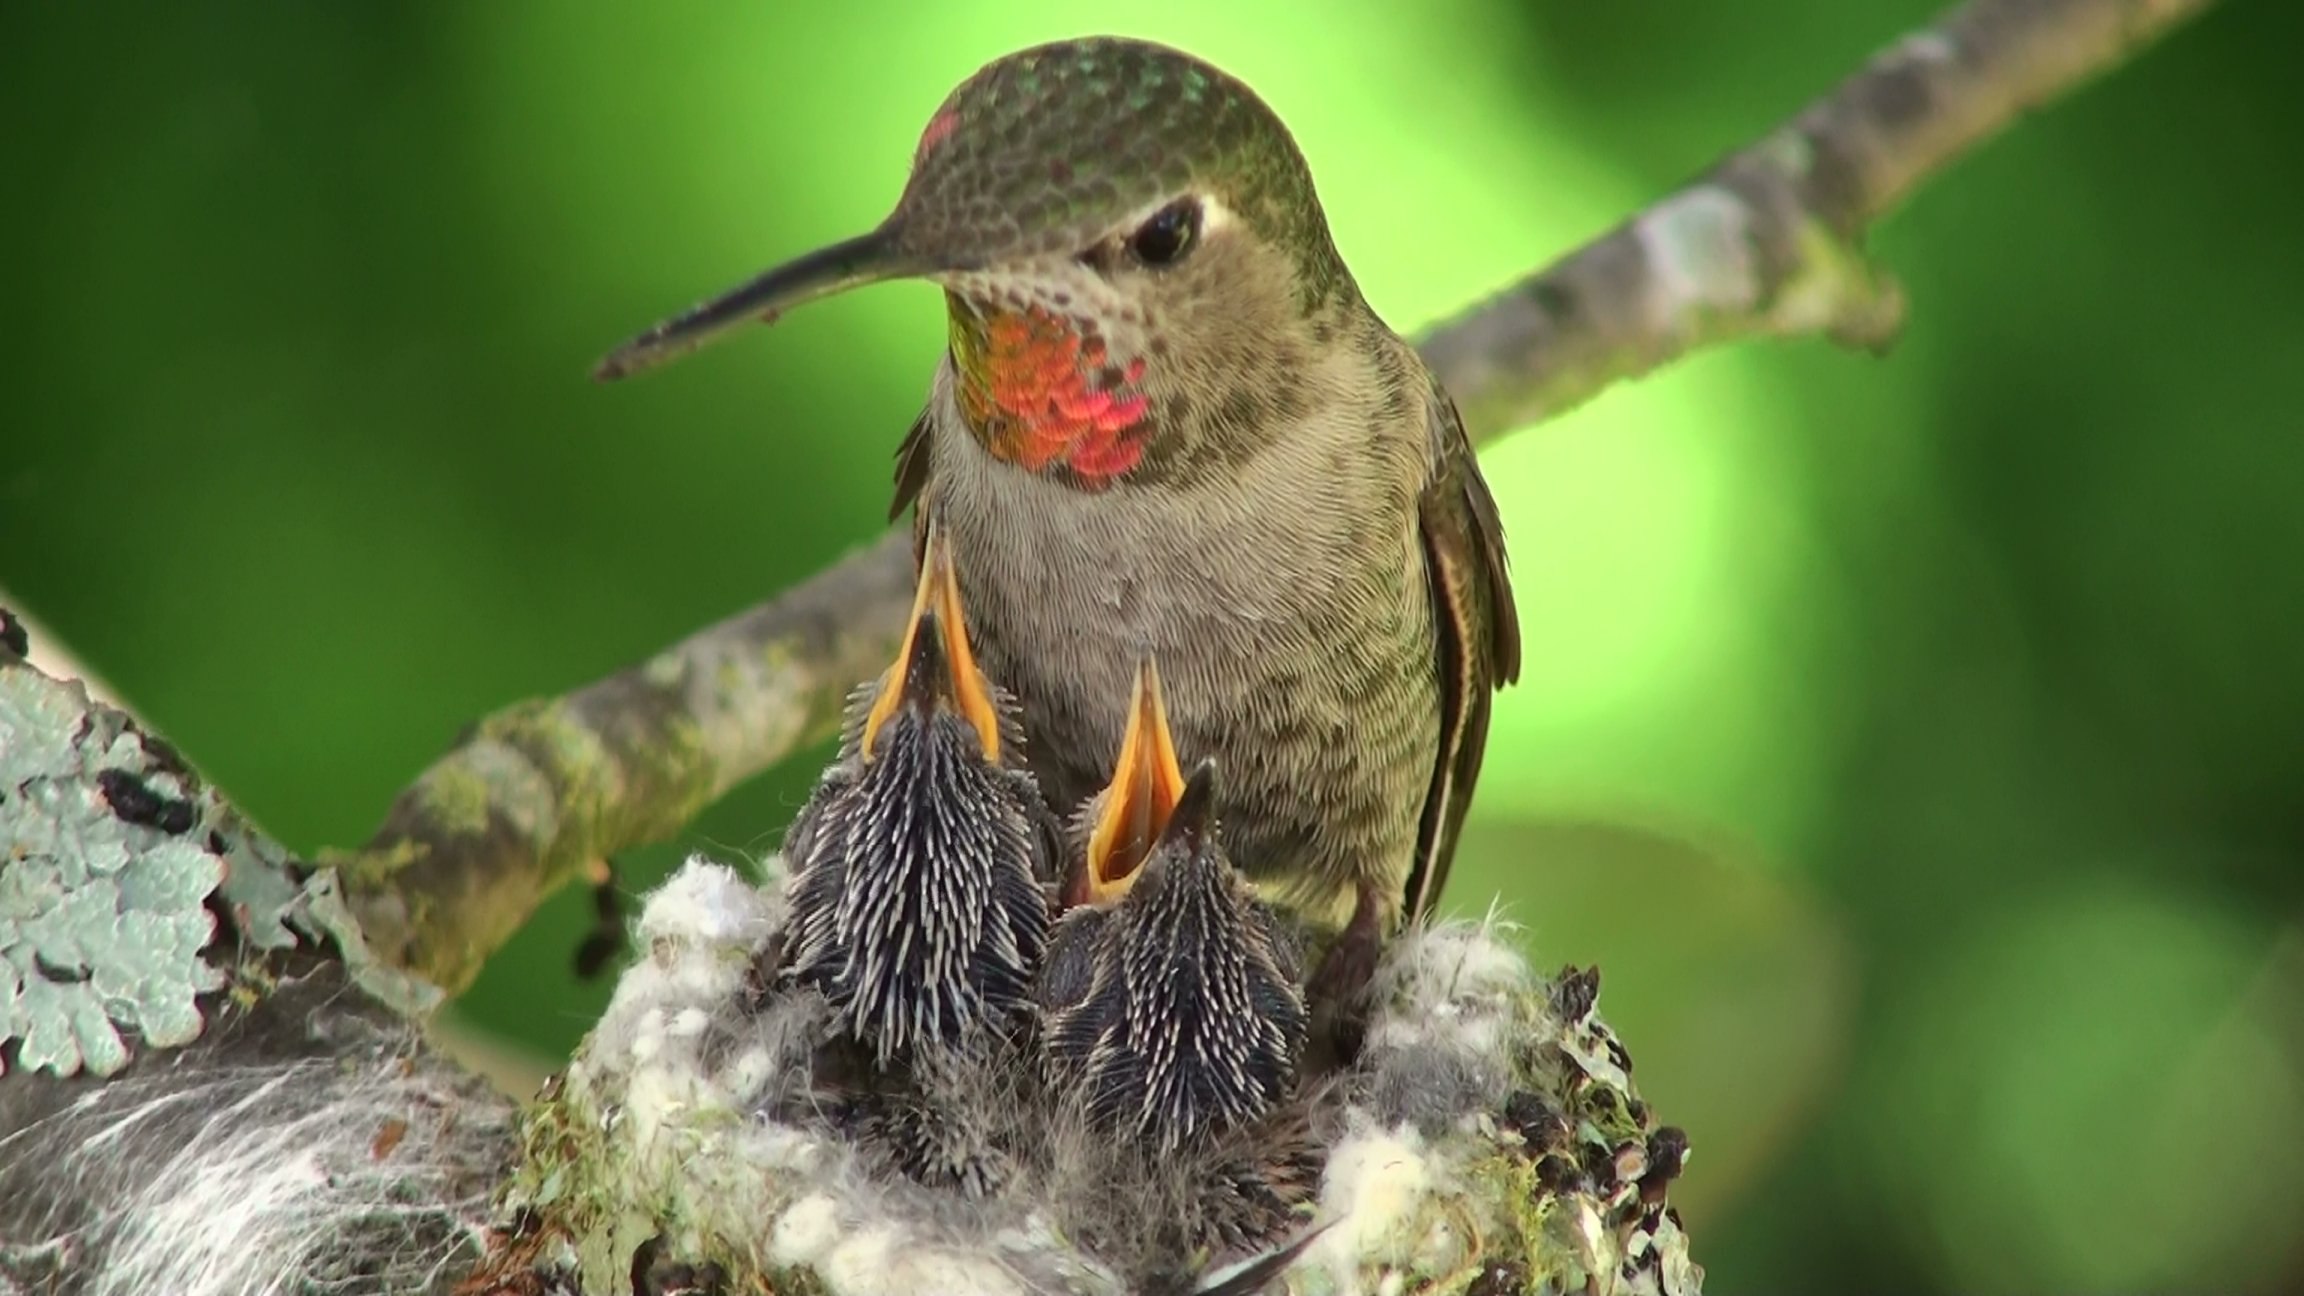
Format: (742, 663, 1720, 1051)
(597, 37, 1518, 1001)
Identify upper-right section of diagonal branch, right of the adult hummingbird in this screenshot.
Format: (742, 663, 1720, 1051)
(1422, 0, 2214, 428)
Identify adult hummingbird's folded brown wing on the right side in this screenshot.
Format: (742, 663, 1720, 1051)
(1405, 380, 1521, 920)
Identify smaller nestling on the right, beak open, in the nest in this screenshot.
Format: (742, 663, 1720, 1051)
(1039, 660, 1306, 1158)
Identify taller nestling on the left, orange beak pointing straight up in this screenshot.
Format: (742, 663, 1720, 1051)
(781, 518, 1060, 1070)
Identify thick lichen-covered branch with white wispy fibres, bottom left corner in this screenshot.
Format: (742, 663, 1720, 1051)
(0, 636, 518, 1296)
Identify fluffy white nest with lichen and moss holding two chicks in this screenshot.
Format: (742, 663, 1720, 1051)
(511, 858, 1703, 1296)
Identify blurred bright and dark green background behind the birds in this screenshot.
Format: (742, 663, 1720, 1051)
(0, 0, 2304, 1291)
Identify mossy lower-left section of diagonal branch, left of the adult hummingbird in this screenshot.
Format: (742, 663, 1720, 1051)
(323, 537, 912, 989)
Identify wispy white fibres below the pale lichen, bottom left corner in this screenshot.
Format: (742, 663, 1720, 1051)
(0, 991, 511, 1296)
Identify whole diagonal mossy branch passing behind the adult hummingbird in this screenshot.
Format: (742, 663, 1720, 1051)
(339, 0, 2212, 989)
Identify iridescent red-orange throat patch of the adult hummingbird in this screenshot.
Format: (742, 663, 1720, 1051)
(952, 304, 1150, 487)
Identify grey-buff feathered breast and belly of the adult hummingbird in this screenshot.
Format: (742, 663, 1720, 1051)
(926, 357, 1440, 913)
